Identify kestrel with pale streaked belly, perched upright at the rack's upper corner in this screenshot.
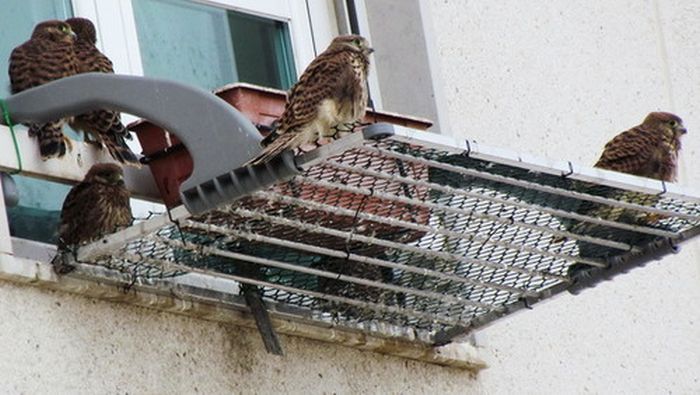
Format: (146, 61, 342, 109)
(247, 35, 374, 164)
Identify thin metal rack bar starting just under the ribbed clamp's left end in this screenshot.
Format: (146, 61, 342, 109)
(184, 220, 535, 295)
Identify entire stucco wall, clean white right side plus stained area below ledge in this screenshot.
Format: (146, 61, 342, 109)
(0, 0, 700, 394)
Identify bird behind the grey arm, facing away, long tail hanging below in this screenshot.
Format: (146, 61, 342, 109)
(66, 18, 140, 167)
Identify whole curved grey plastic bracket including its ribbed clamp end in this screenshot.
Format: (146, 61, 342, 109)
(1, 73, 394, 215)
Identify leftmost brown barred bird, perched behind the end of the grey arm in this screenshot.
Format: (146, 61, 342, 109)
(9, 20, 78, 160)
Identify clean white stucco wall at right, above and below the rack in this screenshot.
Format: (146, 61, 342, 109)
(430, 0, 700, 394)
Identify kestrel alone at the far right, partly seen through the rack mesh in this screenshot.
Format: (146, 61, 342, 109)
(569, 112, 687, 274)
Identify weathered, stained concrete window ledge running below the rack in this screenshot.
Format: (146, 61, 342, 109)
(0, 254, 487, 373)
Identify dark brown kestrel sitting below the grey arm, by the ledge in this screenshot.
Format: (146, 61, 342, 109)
(54, 163, 133, 273)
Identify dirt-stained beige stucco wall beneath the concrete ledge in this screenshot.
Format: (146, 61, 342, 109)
(0, 282, 476, 394)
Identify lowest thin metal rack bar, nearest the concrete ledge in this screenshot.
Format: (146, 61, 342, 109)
(100, 246, 464, 326)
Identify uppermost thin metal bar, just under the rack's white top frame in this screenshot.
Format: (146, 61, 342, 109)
(361, 145, 700, 226)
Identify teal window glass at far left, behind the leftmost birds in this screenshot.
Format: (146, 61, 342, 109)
(0, 0, 72, 243)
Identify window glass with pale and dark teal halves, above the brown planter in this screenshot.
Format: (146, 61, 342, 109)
(132, 0, 296, 89)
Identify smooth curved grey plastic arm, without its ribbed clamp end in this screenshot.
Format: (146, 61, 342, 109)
(0, 73, 270, 213)
